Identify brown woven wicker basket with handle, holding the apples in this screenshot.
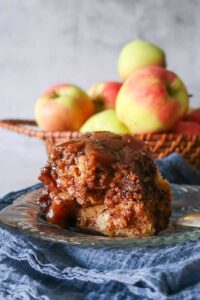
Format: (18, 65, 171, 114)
(0, 120, 200, 169)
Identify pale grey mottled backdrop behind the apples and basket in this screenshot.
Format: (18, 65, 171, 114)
(0, 0, 200, 193)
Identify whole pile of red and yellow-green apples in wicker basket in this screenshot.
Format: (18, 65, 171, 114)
(35, 40, 200, 135)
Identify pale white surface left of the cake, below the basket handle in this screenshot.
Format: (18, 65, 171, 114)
(0, 129, 47, 197)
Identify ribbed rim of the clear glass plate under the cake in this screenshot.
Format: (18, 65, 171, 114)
(0, 184, 200, 248)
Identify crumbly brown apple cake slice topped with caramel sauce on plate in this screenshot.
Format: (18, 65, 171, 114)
(39, 132, 171, 237)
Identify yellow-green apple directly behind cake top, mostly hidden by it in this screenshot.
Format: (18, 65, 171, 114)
(80, 109, 129, 134)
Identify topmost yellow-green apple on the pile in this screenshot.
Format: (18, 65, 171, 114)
(118, 40, 166, 80)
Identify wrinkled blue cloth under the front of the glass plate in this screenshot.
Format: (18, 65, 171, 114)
(0, 154, 200, 300)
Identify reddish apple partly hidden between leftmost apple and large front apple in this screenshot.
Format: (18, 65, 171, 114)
(88, 81, 122, 112)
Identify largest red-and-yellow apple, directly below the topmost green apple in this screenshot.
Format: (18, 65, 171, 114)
(116, 66, 188, 133)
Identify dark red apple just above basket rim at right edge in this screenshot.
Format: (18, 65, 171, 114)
(171, 121, 200, 135)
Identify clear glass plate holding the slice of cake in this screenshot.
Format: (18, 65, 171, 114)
(0, 184, 200, 247)
